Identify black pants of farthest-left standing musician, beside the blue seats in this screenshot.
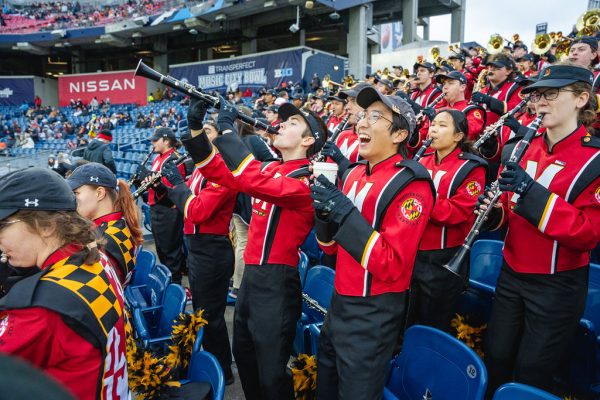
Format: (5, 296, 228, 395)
(150, 204, 185, 283)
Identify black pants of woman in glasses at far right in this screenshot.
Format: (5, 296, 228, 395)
(485, 261, 589, 398)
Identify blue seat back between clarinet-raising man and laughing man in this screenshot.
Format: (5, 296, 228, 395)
(302, 265, 335, 323)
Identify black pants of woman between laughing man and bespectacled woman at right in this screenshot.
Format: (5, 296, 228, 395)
(407, 247, 469, 332)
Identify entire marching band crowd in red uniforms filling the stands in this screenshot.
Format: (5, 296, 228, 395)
(0, 13, 600, 400)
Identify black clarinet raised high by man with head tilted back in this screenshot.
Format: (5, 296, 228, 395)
(133, 60, 277, 135)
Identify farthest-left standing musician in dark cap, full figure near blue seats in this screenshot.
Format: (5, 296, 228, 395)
(140, 128, 186, 283)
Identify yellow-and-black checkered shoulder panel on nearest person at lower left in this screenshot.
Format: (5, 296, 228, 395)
(40, 258, 123, 338)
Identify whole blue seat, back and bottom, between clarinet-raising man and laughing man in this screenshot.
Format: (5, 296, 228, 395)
(294, 265, 335, 355)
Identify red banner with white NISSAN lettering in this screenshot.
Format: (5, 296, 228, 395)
(58, 71, 148, 107)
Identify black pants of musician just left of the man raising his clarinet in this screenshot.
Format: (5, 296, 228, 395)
(186, 234, 234, 379)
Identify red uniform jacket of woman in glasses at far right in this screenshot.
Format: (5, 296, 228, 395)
(492, 126, 600, 274)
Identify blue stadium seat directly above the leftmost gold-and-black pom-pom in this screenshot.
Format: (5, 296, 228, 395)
(133, 284, 186, 347)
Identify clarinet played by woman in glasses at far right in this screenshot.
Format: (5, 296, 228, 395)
(444, 114, 544, 275)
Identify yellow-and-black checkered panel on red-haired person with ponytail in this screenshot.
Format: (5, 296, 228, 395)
(100, 219, 135, 277)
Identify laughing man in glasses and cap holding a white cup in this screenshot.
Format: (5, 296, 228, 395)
(311, 87, 434, 400)
